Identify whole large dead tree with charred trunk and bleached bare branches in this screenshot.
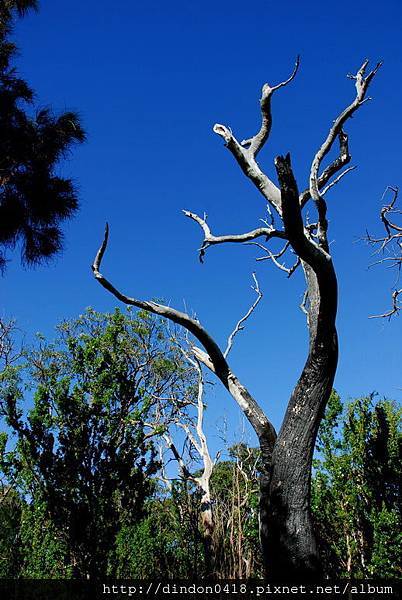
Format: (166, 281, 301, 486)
(93, 59, 380, 579)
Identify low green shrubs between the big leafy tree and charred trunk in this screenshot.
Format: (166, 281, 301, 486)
(113, 444, 261, 578)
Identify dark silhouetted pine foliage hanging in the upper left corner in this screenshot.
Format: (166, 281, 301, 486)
(0, 0, 85, 270)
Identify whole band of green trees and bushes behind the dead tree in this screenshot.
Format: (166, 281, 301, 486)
(0, 309, 402, 579)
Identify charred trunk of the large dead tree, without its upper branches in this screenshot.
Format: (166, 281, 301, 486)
(260, 258, 338, 581)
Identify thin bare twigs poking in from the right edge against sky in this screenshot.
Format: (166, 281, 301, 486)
(366, 185, 402, 319)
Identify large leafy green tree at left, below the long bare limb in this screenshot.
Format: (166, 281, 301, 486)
(0, 310, 195, 577)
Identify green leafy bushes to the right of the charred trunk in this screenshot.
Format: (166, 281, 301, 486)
(312, 392, 402, 578)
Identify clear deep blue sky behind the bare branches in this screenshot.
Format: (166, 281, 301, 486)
(1, 0, 402, 448)
